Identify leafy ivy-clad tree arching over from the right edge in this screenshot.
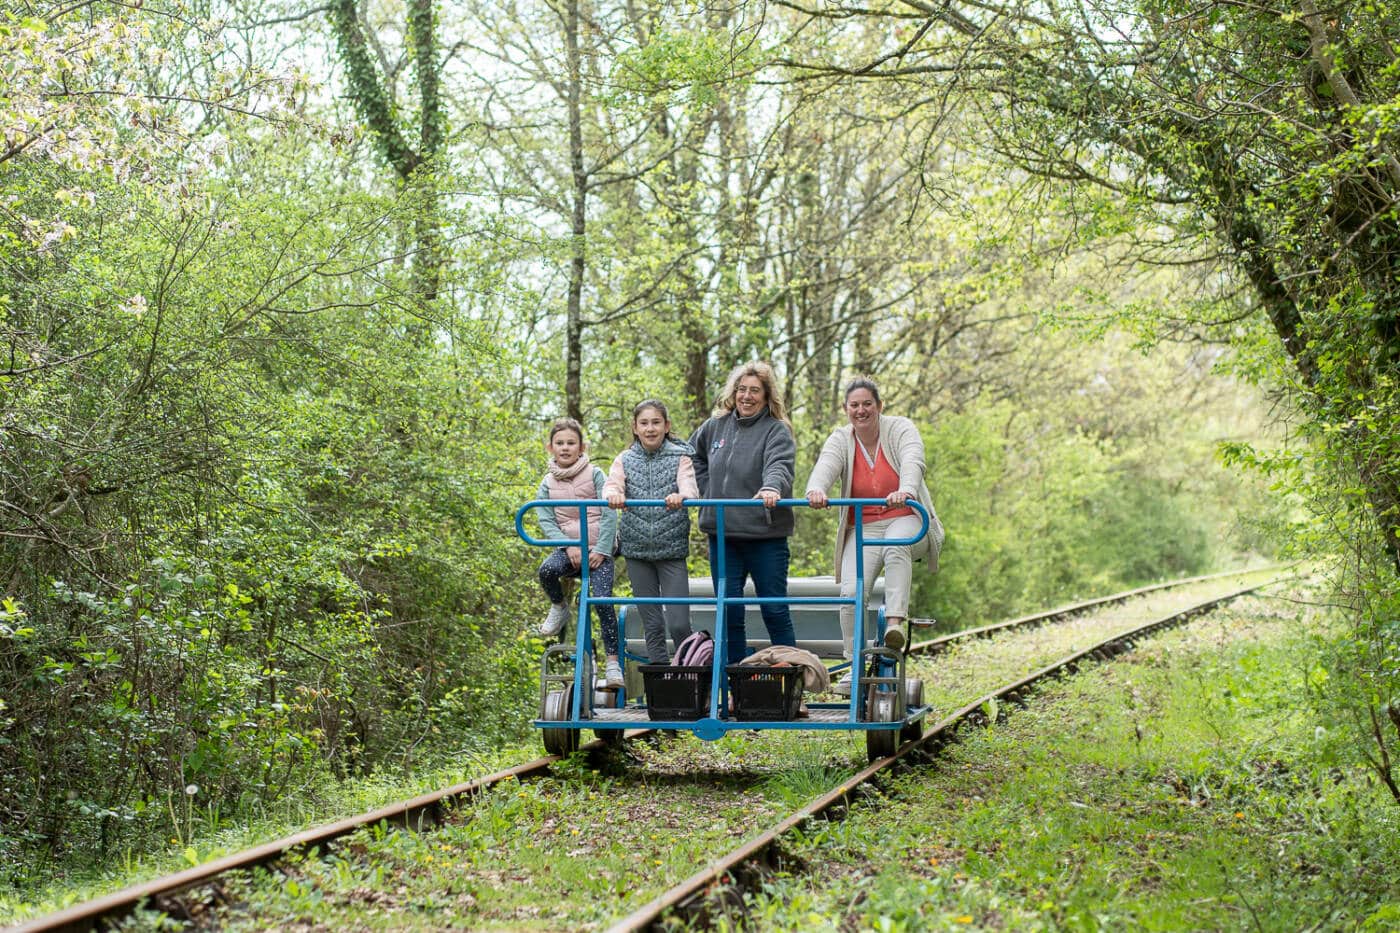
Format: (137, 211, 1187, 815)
(778, 0, 1400, 800)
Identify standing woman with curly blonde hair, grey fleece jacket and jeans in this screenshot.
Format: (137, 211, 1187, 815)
(690, 360, 797, 664)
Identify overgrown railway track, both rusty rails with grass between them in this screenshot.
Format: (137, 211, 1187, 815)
(10, 572, 1282, 930)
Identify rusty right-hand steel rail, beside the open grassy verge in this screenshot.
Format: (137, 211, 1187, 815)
(608, 580, 1277, 933)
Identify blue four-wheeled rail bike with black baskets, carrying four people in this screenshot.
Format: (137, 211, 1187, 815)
(515, 499, 930, 761)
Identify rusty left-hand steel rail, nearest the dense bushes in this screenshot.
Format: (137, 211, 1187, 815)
(6, 570, 1264, 933)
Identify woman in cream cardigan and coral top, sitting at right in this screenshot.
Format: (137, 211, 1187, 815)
(806, 378, 944, 692)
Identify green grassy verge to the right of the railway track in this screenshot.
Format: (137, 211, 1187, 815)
(728, 600, 1400, 932)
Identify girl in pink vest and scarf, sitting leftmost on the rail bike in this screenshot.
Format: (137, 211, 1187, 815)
(535, 417, 623, 686)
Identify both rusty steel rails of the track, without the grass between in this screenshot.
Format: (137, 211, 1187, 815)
(14, 572, 1282, 930)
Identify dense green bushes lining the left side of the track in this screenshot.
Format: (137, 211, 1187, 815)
(0, 119, 538, 884)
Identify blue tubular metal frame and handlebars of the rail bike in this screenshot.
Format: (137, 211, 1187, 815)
(515, 499, 928, 741)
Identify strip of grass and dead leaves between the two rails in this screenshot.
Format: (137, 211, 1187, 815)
(117, 571, 1282, 929)
